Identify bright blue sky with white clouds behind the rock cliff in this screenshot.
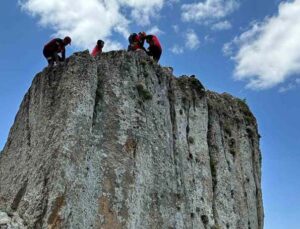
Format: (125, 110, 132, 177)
(0, 0, 300, 229)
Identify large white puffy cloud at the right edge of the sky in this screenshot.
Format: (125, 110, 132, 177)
(223, 0, 300, 89)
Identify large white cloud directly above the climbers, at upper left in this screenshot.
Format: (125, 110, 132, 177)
(19, 0, 165, 50)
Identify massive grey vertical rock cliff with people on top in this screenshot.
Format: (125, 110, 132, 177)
(0, 51, 263, 229)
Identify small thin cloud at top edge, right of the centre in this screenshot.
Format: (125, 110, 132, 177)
(181, 0, 239, 24)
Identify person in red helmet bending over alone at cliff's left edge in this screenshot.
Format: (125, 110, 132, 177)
(43, 36, 71, 66)
